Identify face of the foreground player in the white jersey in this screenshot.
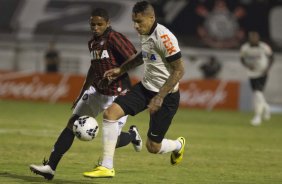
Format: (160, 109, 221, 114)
(132, 13, 155, 35)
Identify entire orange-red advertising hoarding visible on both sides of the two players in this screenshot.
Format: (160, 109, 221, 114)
(0, 72, 240, 110)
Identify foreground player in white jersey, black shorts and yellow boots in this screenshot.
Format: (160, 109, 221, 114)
(83, 1, 185, 178)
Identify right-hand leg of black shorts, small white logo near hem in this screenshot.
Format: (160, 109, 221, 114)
(147, 92, 180, 143)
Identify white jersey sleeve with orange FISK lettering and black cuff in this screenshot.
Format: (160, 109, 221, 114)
(159, 30, 181, 62)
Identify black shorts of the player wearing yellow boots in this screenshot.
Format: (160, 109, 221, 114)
(115, 82, 180, 143)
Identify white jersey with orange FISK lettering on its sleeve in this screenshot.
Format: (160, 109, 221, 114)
(140, 23, 181, 92)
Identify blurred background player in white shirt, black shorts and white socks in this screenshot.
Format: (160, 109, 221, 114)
(240, 31, 273, 126)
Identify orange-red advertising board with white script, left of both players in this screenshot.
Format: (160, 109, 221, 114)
(0, 72, 84, 102)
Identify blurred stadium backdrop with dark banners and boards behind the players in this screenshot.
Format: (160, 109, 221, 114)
(0, 0, 282, 111)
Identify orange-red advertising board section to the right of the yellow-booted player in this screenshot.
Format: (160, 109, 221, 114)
(180, 80, 240, 110)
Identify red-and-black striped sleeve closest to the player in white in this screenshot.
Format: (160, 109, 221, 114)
(109, 32, 137, 60)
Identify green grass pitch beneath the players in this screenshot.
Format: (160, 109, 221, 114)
(0, 100, 282, 184)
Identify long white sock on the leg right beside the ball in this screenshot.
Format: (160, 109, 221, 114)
(102, 119, 118, 169)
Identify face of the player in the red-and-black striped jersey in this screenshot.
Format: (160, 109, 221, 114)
(89, 16, 110, 36)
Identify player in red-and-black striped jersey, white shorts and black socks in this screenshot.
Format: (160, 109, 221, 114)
(30, 8, 142, 180)
